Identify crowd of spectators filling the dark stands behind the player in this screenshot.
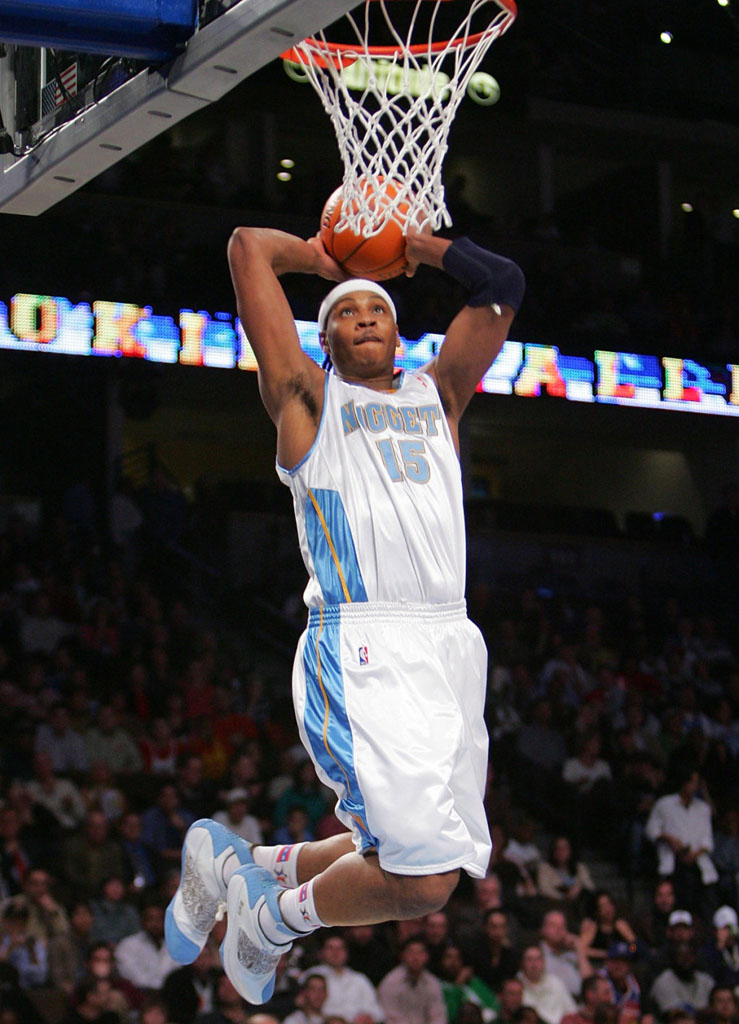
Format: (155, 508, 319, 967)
(0, 468, 739, 1024)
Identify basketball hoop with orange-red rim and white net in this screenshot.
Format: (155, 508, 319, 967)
(282, 0, 517, 237)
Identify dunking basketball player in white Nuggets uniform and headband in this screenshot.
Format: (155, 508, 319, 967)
(167, 227, 524, 1004)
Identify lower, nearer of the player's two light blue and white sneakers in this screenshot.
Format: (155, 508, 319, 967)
(221, 864, 296, 1006)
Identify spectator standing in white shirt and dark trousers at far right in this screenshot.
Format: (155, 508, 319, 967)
(645, 765, 719, 910)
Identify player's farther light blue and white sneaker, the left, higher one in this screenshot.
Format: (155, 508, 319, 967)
(164, 818, 254, 964)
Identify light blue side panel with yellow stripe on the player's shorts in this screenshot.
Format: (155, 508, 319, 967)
(303, 606, 378, 849)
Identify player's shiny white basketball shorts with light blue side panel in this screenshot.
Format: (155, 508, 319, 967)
(293, 601, 490, 878)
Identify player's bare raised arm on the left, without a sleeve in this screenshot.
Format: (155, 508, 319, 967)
(228, 227, 345, 427)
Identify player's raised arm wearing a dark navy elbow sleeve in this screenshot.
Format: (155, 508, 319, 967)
(405, 232, 525, 421)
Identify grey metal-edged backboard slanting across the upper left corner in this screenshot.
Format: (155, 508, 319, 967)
(0, 0, 356, 216)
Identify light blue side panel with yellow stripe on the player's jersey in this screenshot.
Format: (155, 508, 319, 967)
(305, 488, 367, 604)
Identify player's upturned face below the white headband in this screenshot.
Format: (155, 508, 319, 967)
(323, 292, 398, 378)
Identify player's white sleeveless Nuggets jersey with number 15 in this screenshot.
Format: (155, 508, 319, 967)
(277, 373, 465, 608)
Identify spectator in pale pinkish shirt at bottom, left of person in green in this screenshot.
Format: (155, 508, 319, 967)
(375, 936, 446, 1024)
